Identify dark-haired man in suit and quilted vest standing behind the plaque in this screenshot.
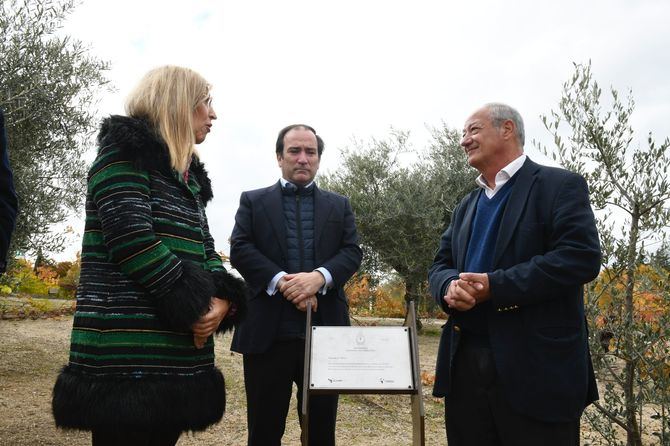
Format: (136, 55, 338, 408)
(230, 125, 362, 446)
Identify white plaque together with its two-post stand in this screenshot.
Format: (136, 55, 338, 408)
(301, 301, 426, 446)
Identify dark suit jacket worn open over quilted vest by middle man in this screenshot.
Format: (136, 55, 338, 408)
(230, 182, 362, 353)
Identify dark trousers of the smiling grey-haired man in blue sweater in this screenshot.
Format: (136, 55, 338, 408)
(444, 334, 579, 446)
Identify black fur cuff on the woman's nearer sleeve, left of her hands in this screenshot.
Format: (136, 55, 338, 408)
(158, 260, 216, 332)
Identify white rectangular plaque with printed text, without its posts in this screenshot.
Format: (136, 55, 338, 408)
(310, 327, 414, 390)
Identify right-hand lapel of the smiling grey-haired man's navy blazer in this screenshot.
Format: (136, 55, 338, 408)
(493, 158, 538, 267)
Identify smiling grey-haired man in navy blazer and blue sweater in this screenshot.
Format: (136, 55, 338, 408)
(429, 104, 601, 446)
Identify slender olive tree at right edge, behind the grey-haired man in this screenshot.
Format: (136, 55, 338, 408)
(542, 63, 670, 446)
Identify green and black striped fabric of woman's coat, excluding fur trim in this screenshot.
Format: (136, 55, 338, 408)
(69, 146, 223, 377)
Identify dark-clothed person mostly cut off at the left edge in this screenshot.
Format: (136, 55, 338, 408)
(0, 109, 17, 274)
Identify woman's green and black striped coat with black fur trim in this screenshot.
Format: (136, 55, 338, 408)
(52, 116, 246, 431)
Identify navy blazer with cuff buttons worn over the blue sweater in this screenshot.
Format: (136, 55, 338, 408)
(428, 159, 601, 422)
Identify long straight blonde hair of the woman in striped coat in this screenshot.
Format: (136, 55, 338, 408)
(126, 65, 210, 173)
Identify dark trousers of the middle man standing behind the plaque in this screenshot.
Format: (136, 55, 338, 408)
(244, 339, 338, 446)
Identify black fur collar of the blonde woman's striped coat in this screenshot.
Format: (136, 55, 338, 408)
(98, 115, 214, 203)
